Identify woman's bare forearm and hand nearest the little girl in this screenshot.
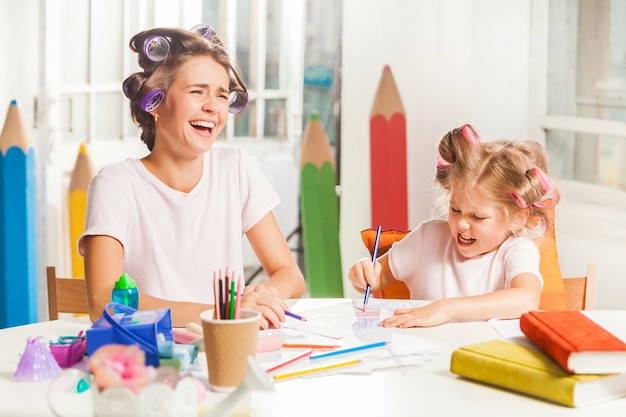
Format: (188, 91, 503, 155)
(241, 212, 305, 328)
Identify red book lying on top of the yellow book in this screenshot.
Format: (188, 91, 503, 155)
(520, 310, 626, 374)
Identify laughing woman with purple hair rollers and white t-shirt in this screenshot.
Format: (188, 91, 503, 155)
(79, 25, 305, 328)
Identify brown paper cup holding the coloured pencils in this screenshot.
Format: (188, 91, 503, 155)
(200, 308, 261, 392)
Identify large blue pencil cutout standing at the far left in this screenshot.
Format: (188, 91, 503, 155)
(0, 100, 37, 328)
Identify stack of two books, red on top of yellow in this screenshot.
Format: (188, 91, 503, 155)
(450, 310, 626, 407)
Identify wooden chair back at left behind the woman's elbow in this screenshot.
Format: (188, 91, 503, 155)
(46, 266, 89, 320)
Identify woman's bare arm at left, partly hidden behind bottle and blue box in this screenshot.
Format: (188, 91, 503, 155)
(84, 236, 213, 327)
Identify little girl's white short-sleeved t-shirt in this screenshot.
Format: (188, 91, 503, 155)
(388, 220, 543, 300)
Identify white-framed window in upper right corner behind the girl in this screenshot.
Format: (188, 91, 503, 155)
(542, 0, 626, 191)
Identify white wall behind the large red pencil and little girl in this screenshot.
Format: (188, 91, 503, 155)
(340, 0, 626, 308)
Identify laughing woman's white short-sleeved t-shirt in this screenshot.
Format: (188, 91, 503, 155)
(78, 147, 280, 303)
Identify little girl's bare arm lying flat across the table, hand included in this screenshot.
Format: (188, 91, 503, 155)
(381, 273, 541, 327)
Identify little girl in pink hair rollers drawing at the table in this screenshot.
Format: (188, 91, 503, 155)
(348, 125, 559, 327)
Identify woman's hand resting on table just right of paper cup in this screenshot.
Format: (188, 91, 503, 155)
(241, 284, 288, 329)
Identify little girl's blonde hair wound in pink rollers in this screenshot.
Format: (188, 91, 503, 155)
(435, 124, 559, 237)
